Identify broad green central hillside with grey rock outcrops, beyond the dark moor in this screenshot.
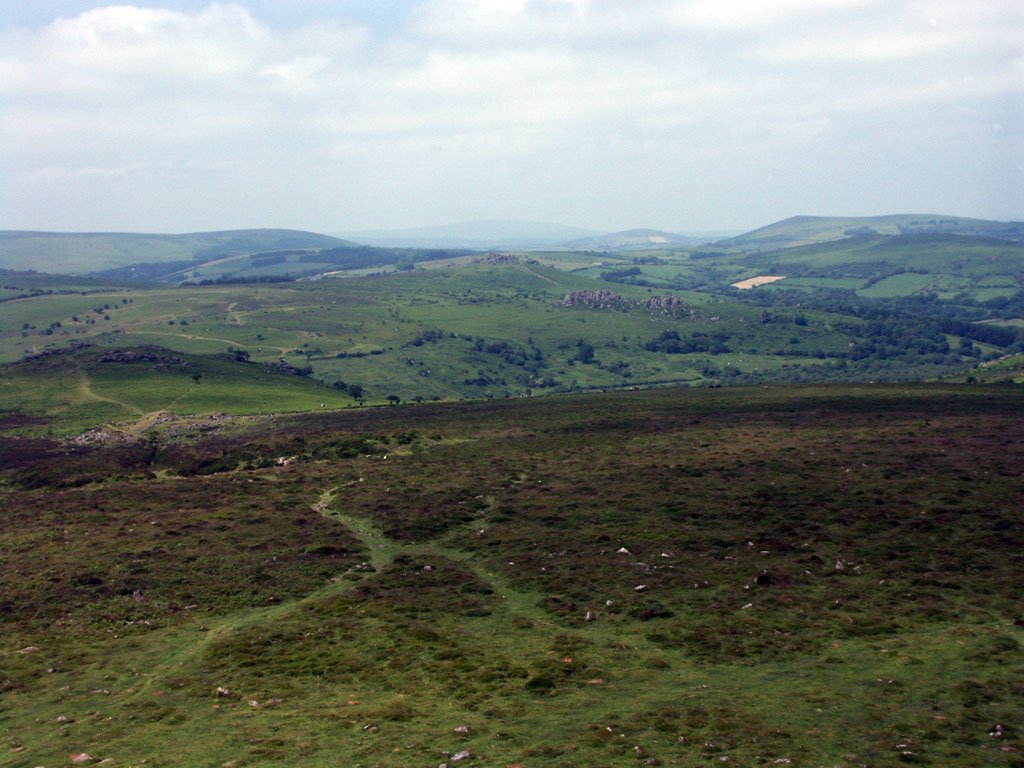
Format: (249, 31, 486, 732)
(0, 263, 872, 411)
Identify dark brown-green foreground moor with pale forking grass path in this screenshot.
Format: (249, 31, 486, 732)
(0, 387, 1024, 768)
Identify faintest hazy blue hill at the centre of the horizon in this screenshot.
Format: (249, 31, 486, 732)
(333, 220, 599, 251)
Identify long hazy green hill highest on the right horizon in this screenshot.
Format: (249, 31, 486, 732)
(717, 214, 1024, 253)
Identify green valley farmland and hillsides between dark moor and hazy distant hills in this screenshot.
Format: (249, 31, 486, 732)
(0, 234, 1024, 434)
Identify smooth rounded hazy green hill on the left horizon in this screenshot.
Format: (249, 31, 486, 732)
(0, 229, 354, 274)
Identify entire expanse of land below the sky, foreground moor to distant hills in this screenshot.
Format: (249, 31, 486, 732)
(0, 211, 1024, 768)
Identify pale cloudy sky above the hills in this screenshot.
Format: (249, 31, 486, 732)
(0, 0, 1024, 232)
